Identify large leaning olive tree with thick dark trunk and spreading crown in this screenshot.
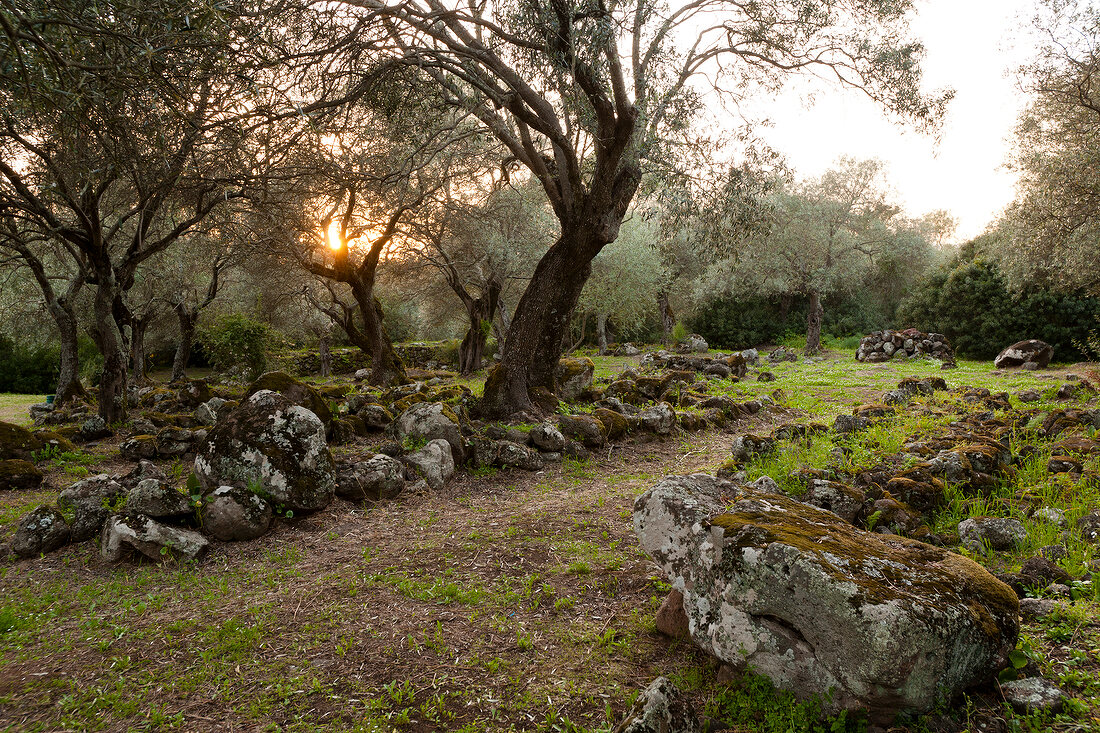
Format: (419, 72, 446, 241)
(347, 0, 945, 415)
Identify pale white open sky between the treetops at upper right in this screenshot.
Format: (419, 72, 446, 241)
(761, 0, 1035, 241)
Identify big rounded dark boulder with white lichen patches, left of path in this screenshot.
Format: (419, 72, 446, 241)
(195, 390, 336, 512)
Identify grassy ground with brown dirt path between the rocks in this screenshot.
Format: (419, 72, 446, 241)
(0, 352, 1100, 732)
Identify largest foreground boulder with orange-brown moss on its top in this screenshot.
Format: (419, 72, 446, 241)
(634, 474, 1019, 721)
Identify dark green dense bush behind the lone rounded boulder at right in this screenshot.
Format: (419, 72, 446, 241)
(898, 255, 1100, 361)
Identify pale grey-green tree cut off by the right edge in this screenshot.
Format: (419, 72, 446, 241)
(996, 0, 1100, 294)
